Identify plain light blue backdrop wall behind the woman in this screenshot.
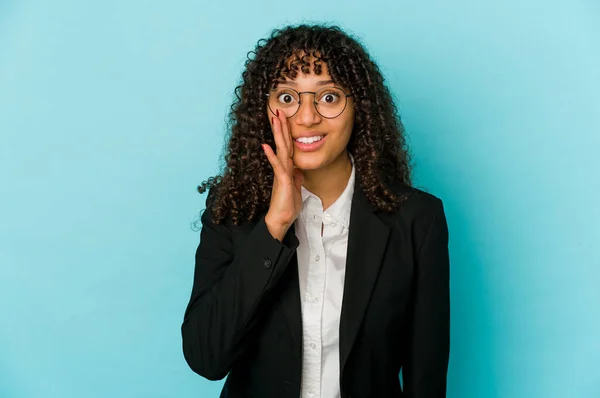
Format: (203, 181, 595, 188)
(0, 0, 600, 398)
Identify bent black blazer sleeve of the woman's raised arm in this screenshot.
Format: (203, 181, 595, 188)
(181, 192, 298, 380)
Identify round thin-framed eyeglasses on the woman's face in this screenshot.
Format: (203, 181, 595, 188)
(267, 87, 352, 119)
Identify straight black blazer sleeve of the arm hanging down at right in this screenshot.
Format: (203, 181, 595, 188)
(402, 198, 450, 398)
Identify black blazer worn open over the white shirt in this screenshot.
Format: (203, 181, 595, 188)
(181, 181, 450, 398)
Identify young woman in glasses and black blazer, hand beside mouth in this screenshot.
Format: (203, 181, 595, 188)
(181, 25, 450, 398)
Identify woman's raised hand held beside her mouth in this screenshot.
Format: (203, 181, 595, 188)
(262, 111, 303, 241)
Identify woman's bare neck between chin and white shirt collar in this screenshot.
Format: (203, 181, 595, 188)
(303, 151, 352, 210)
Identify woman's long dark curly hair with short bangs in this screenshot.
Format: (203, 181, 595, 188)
(198, 24, 412, 225)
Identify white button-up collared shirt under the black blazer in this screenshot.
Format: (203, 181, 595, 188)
(294, 155, 355, 398)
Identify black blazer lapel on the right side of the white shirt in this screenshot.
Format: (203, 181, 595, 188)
(339, 185, 390, 378)
